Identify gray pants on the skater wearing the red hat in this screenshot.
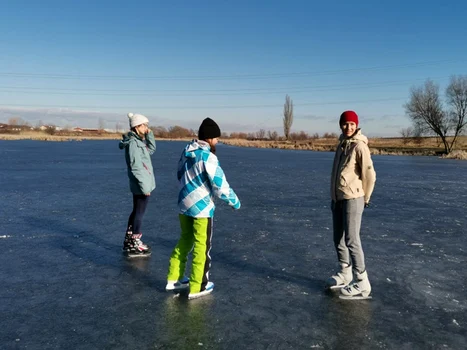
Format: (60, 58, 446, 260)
(331, 197, 365, 273)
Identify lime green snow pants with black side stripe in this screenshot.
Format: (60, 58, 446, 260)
(167, 214, 212, 293)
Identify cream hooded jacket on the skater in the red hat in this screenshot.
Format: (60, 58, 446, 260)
(331, 129, 376, 203)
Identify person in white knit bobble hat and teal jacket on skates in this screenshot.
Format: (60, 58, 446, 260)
(119, 113, 156, 258)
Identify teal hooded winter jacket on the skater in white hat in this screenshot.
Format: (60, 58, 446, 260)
(118, 131, 156, 194)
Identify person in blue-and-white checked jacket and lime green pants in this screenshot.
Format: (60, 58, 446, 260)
(166, 118, 240, 299)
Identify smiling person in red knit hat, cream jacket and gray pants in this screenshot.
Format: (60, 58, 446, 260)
(327, 111, 376, 299)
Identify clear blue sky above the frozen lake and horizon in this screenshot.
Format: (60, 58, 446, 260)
(0, 0, 467, 136)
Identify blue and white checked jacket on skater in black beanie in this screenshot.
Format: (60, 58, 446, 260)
(177, 140, 240, 218)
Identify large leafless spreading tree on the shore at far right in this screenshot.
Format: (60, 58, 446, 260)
(404, 76, 467, 154)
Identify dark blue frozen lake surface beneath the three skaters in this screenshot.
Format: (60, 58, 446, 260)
(0, 141, 467, 350)
